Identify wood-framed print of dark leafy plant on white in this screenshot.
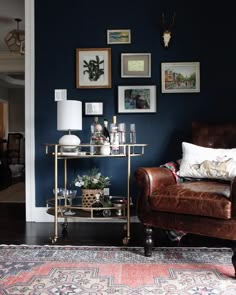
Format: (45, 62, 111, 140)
(76, 48, 111, 88)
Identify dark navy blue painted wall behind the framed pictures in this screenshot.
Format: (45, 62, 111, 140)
(35, 0, 236, 206)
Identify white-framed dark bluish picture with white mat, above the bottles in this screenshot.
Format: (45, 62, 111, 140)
(118, 85, 157, 114)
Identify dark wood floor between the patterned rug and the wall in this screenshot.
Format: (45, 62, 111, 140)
(0, 203, 231, 247)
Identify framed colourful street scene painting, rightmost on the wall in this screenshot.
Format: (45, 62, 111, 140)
(161, 62, 200, 93)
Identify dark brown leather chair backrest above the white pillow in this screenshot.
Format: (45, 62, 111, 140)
(192, 122, 236, 148)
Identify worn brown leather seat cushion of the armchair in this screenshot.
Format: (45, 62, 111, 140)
(149, 181, 231, 219)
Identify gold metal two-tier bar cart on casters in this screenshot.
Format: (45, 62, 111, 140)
(45, 144, 147, 245)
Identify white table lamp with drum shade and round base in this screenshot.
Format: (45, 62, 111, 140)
(57, 100, 82, 146)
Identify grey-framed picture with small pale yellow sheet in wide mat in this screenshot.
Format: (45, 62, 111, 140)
(121, 53, 151, 78)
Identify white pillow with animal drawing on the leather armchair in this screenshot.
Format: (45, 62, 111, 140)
(178, 142, 236, 180)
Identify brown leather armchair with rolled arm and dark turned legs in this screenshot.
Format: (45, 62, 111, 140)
(134, 122, 236, 278)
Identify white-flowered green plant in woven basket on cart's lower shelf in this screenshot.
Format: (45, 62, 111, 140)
(74, 168, 110, 207)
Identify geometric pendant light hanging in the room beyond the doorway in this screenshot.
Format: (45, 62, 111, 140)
(5, 18, 25, 54)
